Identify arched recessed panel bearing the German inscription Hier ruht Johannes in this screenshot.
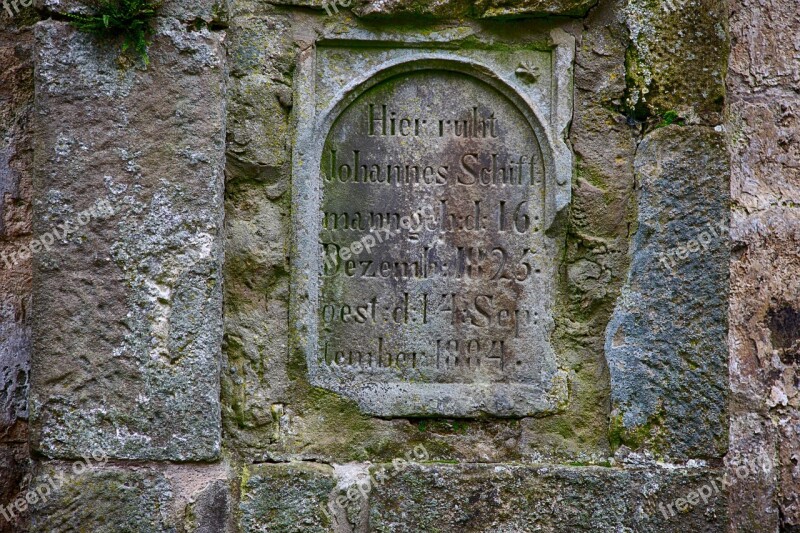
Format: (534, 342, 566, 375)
(316, 71, 553, 386)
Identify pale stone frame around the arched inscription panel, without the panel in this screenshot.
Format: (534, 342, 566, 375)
(290, 38, 574, 417)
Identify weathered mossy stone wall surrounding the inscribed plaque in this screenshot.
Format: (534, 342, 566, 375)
(0, 0, 800, 532)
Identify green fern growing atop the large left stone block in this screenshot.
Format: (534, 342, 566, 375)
(68, 0, 160, 66)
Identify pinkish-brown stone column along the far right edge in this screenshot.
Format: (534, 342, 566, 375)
(726, 0, 800, 532)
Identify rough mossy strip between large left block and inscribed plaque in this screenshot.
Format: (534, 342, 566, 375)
(222, 9, 295, 458)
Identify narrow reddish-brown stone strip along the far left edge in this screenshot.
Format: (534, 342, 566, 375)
(0, 12, 36, 533)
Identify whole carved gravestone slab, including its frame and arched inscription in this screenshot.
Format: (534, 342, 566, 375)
(292, 34, 572, 417)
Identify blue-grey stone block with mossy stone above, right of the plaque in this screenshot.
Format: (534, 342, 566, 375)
(605, 0, 729, 461)
